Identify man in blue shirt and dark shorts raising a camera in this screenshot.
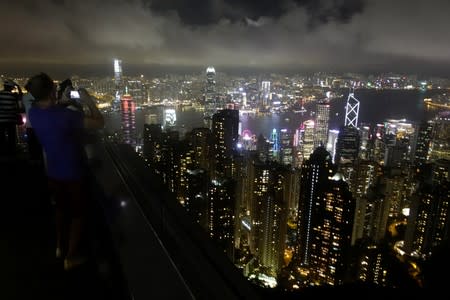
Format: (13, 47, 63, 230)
(27, 73, 104, 270)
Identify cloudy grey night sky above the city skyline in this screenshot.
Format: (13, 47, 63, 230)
(0, 0, 450, 73)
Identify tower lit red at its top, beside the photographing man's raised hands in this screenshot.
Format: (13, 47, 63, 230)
(121, 95, 136, 146)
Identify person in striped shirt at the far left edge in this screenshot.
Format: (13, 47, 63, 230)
(0, 79, 20, 155)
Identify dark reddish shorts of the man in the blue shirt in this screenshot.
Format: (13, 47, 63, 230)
(48, 178, 87, 218)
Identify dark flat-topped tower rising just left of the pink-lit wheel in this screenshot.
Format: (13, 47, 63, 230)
(212, 109, 239, 178)
